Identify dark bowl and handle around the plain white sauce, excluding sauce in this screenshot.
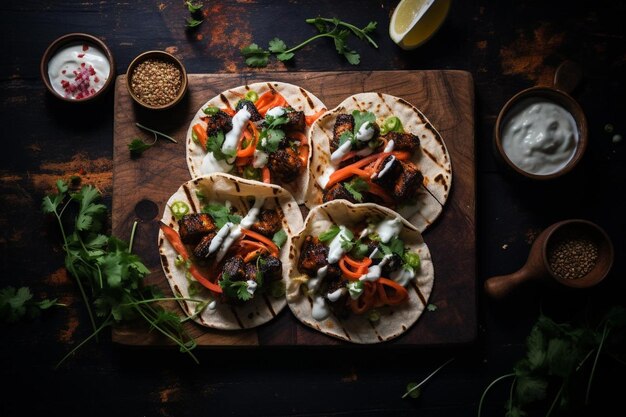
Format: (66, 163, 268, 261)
(493, 61, 588, 181)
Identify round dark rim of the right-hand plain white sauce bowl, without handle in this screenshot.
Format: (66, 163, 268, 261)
(493, 86, 589, 181)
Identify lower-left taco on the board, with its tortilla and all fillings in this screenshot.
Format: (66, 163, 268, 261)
(158, 174, 302, 330)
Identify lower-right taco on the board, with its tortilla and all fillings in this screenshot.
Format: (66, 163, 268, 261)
(287, 200, 435, 344)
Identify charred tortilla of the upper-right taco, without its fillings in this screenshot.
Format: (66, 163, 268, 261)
(305, 93, 452, 231)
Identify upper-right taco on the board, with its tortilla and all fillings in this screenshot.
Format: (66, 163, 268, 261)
(306, 93, 452, 231)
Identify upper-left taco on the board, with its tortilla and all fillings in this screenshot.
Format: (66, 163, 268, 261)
(187, 82, 326, 204)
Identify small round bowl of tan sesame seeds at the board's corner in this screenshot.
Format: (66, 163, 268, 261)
(126, 51, 187, 110)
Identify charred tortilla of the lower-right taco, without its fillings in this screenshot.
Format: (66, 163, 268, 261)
(287, 200, 435, 344)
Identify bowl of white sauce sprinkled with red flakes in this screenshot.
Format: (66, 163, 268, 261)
(40, 33, 115, 102)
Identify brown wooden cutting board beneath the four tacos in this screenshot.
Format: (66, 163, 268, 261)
(112, 70, 477, 346)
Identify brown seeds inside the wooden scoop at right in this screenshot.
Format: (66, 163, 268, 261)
(547, 231, 598, 279)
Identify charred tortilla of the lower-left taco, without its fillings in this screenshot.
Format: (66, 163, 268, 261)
(158, 173, 302, 330)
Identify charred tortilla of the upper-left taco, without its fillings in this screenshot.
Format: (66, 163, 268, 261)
(187, 81, 326, 204)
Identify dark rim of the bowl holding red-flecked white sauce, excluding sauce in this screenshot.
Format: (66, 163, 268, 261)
(39, 32, 115, 103)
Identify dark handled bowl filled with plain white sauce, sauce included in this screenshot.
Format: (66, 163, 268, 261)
(494, 63, 588, 180)
